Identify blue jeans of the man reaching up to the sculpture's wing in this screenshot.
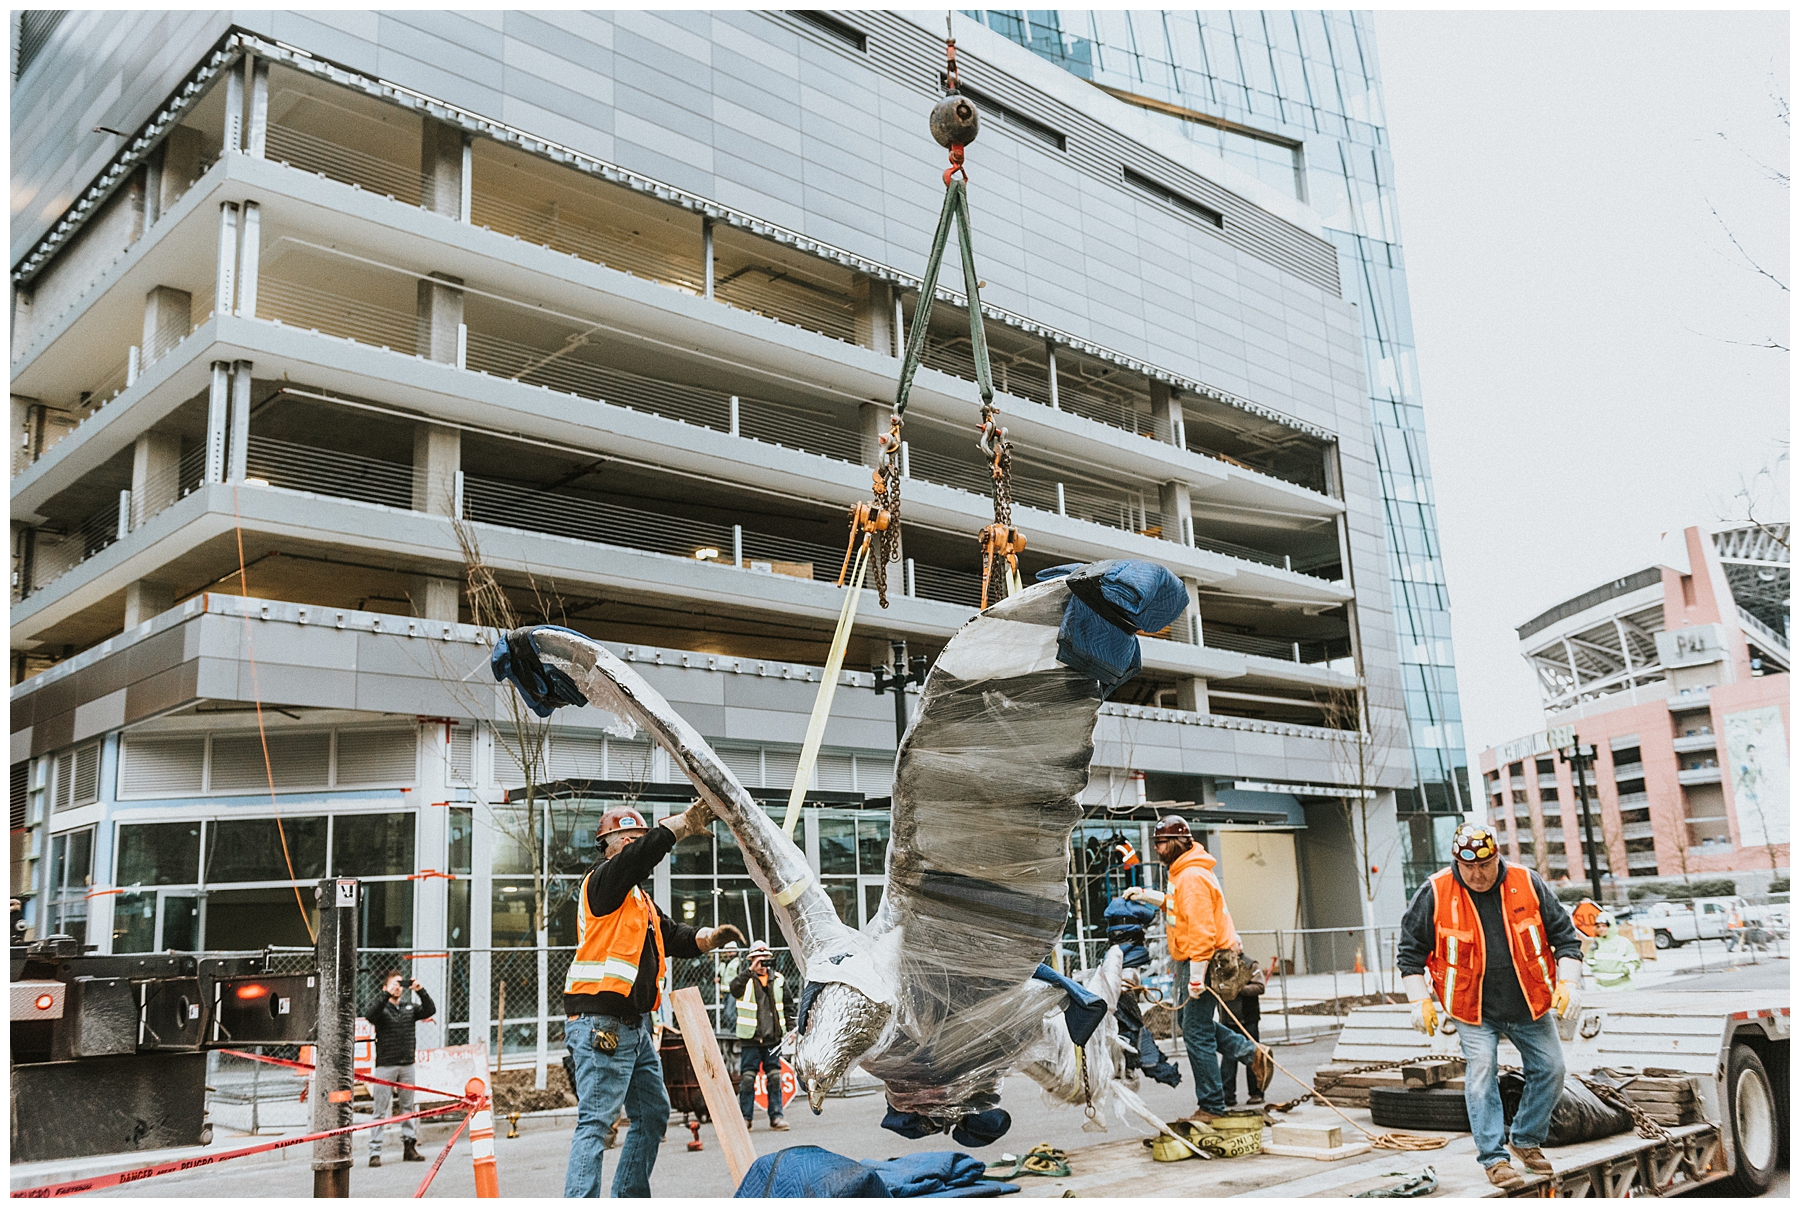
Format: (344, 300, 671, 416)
(563, 1015, 670, 1199)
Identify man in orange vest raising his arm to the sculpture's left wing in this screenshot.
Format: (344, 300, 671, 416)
(563, 801, 743, 1199)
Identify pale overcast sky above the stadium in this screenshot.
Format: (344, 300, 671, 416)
(1375, 11, 1791, 769)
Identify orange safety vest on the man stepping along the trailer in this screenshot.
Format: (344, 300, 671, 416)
(1426, 864, 1555, 1024)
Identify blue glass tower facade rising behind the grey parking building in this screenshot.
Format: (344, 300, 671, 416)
(967, 9, 1472, 893)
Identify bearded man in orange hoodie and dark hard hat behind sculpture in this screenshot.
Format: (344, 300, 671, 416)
(1121, 814, 1274, 1123)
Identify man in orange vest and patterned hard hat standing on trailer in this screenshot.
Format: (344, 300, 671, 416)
(1395, 823, 1580, 1190)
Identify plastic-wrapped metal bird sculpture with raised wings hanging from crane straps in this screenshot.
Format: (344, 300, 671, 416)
(493, 562, 1188, 1145)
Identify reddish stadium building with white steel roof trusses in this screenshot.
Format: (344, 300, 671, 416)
(1481, 522, 1789, 893)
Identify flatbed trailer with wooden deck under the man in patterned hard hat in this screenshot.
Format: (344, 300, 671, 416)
(1021, 990, 1791, 1199)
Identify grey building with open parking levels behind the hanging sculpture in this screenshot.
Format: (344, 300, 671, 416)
(11, 11, 1418, 1046)
